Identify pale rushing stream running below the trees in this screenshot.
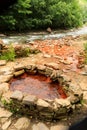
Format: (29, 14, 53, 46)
(0, 26, 87, 44)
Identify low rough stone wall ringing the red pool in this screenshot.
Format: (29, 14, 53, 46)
(0, 64, 81, 121)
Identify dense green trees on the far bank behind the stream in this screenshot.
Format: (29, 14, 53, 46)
(0, 0, 87, 31)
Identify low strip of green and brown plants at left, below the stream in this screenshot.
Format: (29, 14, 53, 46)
(0, 44, 40, 61)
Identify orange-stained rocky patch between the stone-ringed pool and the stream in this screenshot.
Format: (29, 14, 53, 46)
(34, 39, 84, 72)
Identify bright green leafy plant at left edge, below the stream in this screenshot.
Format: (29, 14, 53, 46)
(0, 44, 15, 61)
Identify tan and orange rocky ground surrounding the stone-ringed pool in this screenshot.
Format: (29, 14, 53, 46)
(0, 36, 87, 130)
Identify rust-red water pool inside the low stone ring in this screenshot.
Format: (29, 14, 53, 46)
(10, 73, 67, 99)
